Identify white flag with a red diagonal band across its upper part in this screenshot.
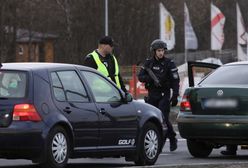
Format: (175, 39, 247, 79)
(211, 3, 226, 50)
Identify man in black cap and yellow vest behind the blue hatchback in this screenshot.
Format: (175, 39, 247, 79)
(84, 36, 127, 92)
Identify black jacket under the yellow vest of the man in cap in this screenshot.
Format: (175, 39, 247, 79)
(83, 50, 127, 92)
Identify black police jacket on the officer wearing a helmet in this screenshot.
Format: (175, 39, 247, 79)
(138, 57, 180, 96)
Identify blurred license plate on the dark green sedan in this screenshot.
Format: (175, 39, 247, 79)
(204, 99, 238, 108)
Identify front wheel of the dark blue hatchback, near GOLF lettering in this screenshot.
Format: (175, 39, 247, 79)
(135, 123, 162, 166)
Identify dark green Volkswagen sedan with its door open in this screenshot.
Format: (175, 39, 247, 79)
(177, 62, 248, 157)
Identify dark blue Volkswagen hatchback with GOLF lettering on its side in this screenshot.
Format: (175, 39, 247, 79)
(0, 63, 166, 168)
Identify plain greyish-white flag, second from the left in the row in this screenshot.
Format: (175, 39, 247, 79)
(184, 3, 198, 50)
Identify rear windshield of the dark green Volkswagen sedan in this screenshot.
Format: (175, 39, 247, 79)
(199, 65, 248, 86)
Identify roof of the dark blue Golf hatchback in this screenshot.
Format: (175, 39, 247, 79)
(0, 62, 92, 71)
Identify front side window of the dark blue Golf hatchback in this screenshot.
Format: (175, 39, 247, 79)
(81, 71, 121, 103)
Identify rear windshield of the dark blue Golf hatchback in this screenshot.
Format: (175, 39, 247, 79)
(0, 71, 27, 98)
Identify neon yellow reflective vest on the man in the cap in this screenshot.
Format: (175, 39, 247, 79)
(90, 51, 121, 88)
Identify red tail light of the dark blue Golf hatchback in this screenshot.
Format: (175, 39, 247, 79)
(13, 104, 41, 121)
